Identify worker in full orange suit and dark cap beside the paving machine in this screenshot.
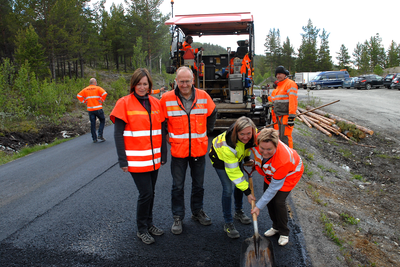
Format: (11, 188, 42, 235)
(268, 66, 297, 148)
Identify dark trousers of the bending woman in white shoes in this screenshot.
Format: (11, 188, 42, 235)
(264, 182, 290, 236)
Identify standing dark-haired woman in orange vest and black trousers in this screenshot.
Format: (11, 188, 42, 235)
(110, 68, 167, 245)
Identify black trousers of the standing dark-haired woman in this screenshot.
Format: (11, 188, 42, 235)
(130, 170, 158, 233)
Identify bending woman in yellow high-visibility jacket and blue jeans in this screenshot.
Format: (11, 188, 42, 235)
(209, 117, 256, 238)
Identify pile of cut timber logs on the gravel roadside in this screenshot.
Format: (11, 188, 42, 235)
(296, 106, 374, 140)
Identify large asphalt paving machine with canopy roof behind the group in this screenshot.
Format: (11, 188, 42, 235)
(165, 12, 271, 130)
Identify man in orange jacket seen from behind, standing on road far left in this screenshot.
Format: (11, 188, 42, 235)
(76, 78, 107, 143)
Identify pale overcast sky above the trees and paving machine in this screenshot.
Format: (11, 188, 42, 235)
(106, 0, 400, 63)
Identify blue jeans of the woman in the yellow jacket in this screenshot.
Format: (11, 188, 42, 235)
(214, 168, 243, 223)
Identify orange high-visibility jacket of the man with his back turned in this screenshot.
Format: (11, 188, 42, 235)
(76, 85, 107, 111)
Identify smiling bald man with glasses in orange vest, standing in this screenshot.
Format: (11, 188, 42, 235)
(161, 66, 217, 235)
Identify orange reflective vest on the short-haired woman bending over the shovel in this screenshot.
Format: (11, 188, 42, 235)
(251, 141, 304, 192)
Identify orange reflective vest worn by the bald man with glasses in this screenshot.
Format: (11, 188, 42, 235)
(161, 87, 215, 158)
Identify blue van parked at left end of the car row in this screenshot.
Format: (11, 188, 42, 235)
(310, 71, 350, 90)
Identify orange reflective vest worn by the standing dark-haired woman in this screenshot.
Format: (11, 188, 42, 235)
(110, 94, 165, 172)
